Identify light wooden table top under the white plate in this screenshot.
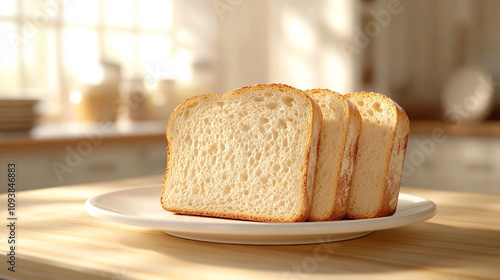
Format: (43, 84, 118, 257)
(0, 175, 500, 280)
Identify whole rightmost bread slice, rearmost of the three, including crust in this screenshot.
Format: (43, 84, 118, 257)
(345, 92, 410, 219)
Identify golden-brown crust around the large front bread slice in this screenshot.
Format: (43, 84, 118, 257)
(161, 84, 322, 222)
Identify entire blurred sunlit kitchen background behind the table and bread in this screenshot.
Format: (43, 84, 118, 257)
(0, 0, 500, 193)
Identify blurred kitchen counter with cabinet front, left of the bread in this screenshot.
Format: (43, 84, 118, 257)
(0, 121, 167, 190)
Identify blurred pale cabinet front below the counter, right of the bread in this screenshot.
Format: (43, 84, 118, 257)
(402, 134, 500, 194)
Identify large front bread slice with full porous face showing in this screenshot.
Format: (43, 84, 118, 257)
(161, 84, 322, 222)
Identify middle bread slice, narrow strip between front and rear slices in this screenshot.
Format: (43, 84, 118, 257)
(306, 89, 361, 221)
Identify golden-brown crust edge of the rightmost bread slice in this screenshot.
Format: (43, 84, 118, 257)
(345, 91, 410, 219)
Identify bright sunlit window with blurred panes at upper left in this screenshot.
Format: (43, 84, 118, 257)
(0, 0, 174, 116)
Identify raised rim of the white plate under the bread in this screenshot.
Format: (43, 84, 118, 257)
(85, 184, 437, 235)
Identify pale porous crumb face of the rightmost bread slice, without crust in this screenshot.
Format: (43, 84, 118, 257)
(346, 92, 404, 218)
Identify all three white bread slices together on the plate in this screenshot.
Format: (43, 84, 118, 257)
(161, 84, 409, 222)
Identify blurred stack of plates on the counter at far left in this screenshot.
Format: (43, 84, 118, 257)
(0, 99, 38, 131)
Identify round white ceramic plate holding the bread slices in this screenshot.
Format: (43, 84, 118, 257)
(85, 185, 436, 245)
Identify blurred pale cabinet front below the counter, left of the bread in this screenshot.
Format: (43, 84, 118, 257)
(0, 139, 167, 192)
